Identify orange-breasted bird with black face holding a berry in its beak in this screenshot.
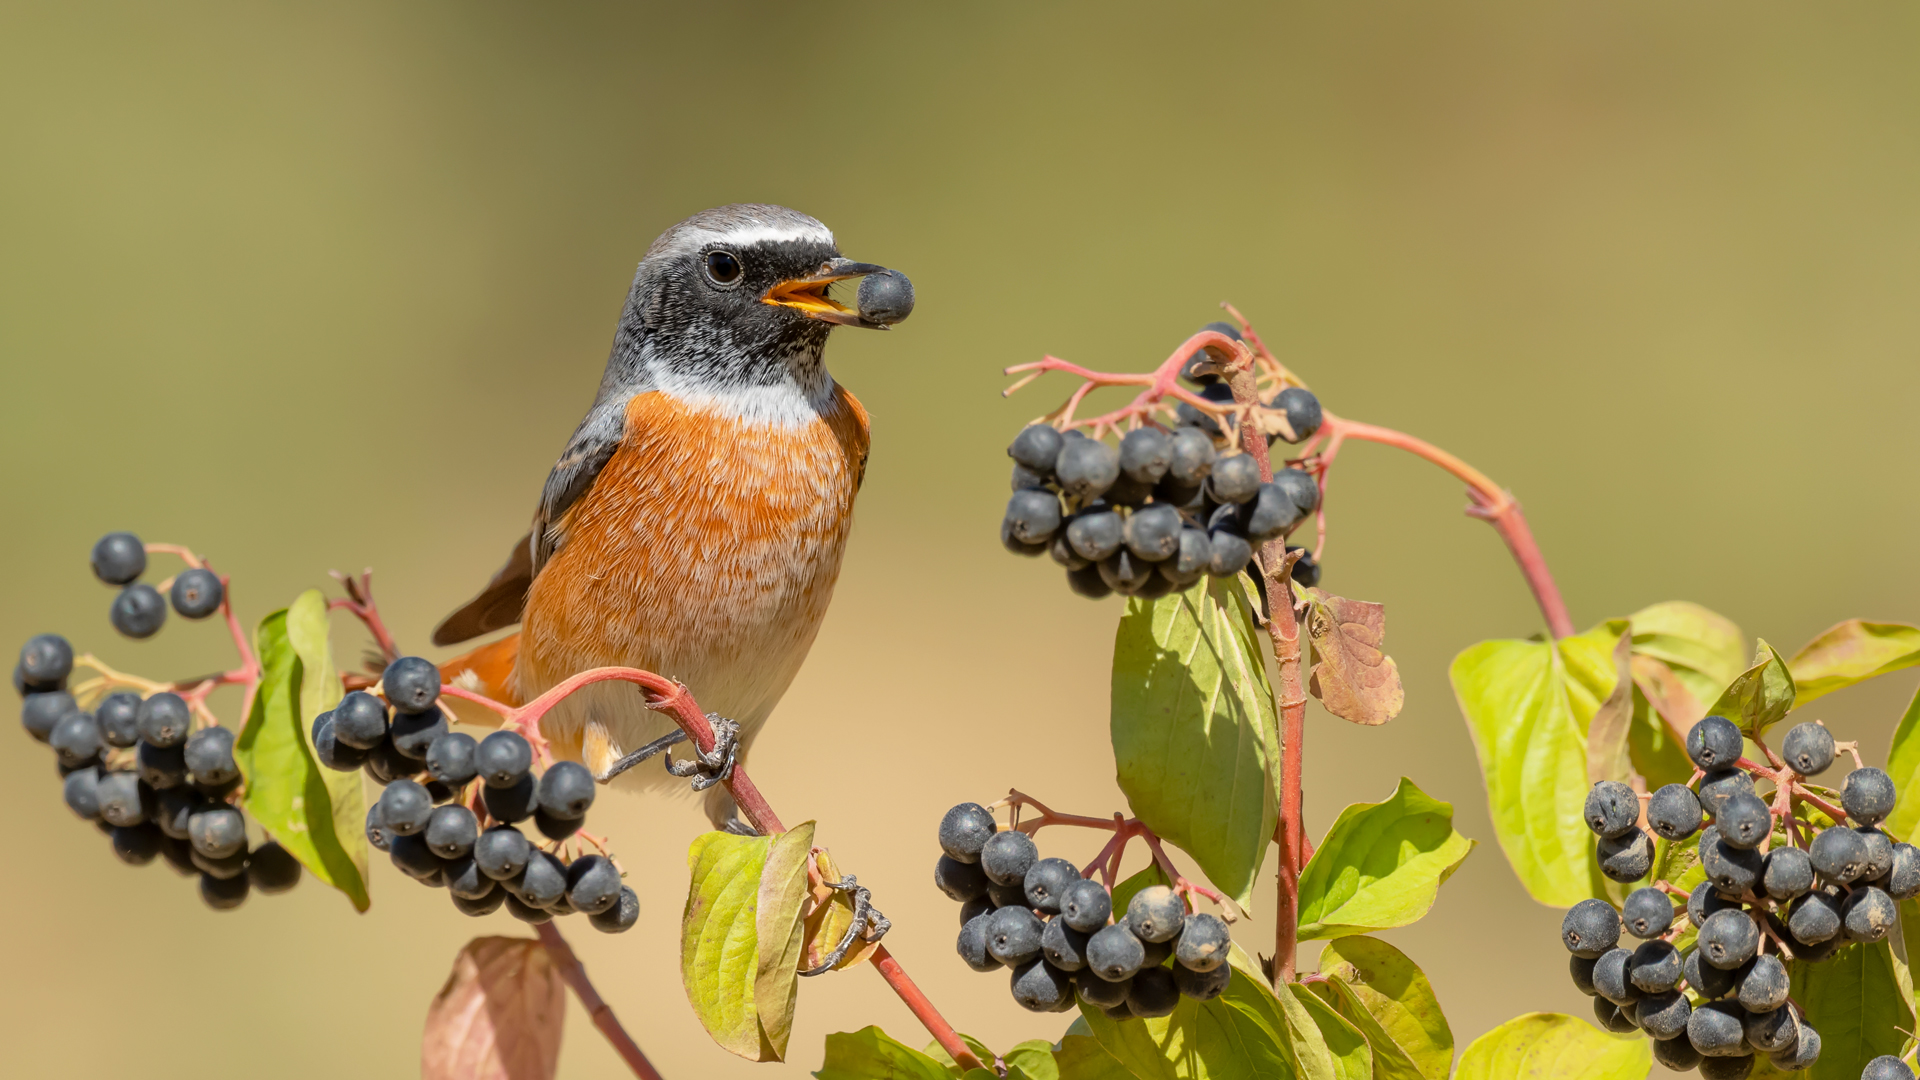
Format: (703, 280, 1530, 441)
(432, 204, 910, 832)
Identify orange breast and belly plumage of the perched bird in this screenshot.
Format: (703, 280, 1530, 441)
(515, 378, 868, 751)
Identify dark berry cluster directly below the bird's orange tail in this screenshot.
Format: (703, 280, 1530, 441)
(334, 657, 639, 934)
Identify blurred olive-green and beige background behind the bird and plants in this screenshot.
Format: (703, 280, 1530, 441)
(0, 2, 1920, 1080)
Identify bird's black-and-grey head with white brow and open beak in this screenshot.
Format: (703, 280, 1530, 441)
(614, 204, 906, 395)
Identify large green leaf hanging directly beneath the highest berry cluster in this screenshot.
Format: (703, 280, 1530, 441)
(1112, 578, 1279, 907)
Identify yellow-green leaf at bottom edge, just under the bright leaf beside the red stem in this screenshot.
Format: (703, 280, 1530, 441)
(1315, 938, 1453, 1080)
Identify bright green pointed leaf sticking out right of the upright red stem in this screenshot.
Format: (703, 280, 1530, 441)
(1300, 776, 1473, 942)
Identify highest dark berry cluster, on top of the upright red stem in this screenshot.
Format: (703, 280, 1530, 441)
(1000, 323, 1321, 600)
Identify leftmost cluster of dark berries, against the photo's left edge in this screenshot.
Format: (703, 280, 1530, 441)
(13, 626, 300, 911)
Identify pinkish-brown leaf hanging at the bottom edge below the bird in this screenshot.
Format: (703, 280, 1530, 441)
(420, 938, 566, 1080)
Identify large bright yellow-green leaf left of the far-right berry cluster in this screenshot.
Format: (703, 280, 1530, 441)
(1448, 623, 1626, 907)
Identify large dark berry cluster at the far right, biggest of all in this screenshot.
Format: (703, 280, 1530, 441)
(1561, 717, 1920, 1080)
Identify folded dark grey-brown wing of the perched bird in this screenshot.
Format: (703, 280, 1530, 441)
(434, 402, 626, 646)
